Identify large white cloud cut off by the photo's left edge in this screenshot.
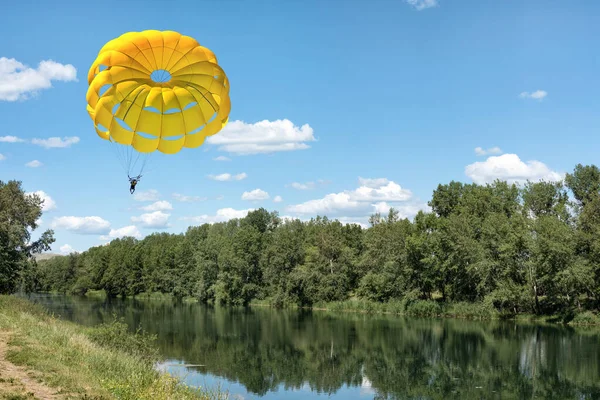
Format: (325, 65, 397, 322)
(0, 57, 77, 101)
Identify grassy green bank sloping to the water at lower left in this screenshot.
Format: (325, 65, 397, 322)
(0, 296, 225, 400)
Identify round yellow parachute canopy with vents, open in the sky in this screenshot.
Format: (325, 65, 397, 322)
(86, 30, 231, 174)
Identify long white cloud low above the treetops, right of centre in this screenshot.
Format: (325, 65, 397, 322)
(287, 178, 412, 214)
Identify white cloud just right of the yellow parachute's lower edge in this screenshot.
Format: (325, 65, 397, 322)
(206, 119, 316, 155)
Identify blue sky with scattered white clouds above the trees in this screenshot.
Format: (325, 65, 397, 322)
(0, 0, 600, 252)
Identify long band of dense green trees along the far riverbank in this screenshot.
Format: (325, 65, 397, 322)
(0, 164, 600, 315)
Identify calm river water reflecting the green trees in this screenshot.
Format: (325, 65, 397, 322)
(22, 295, 600, 400)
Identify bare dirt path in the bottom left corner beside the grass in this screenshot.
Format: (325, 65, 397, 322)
(0, 331, 64, 400)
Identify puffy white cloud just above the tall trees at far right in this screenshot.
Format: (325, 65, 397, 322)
(465, 154, 564, 184)
